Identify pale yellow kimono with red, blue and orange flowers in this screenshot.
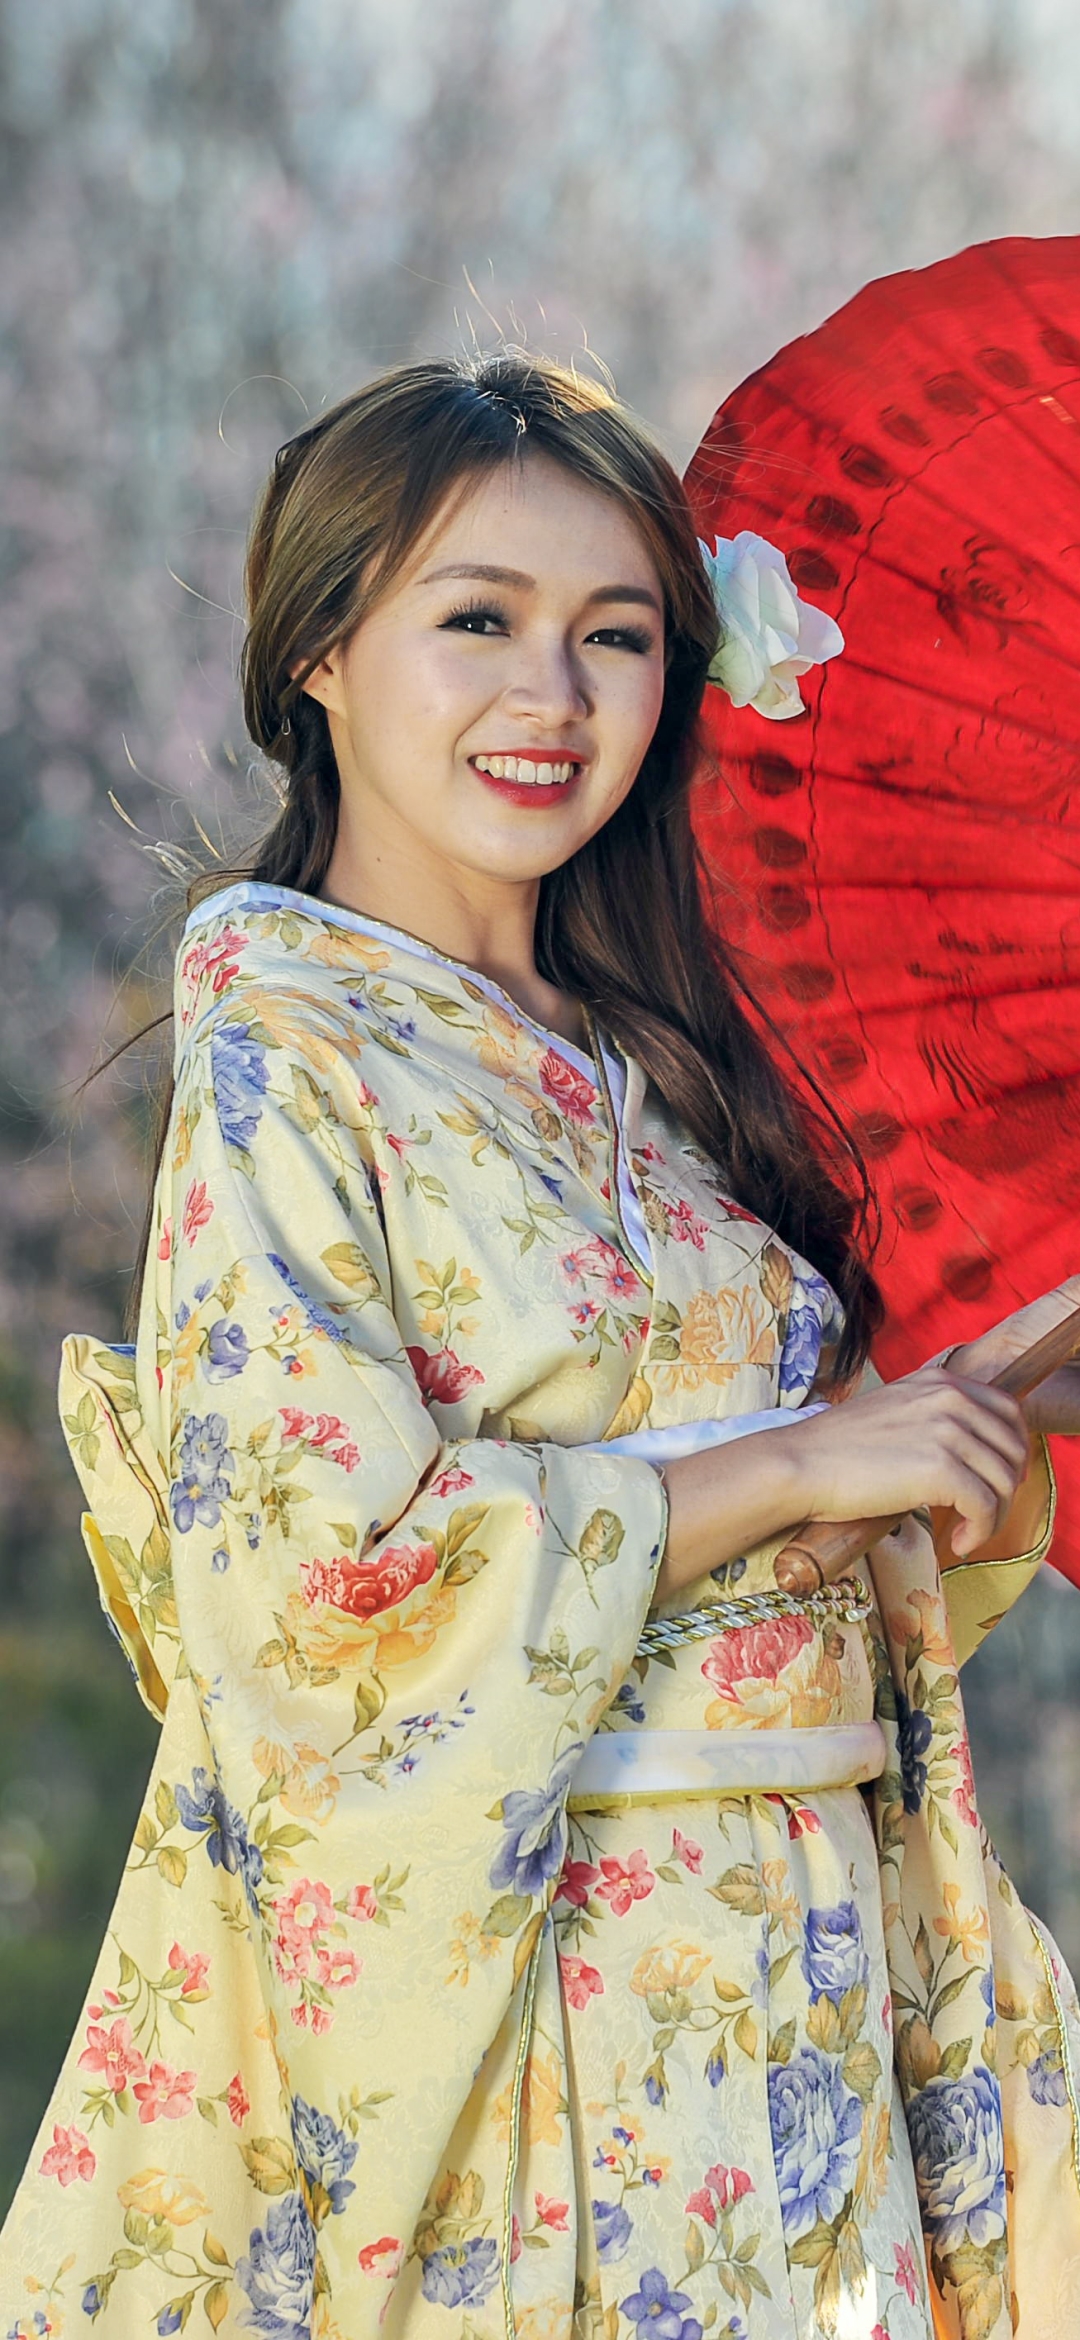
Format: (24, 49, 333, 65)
(0, 885, 1080, 2340)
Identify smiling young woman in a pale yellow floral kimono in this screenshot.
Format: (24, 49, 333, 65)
(2, 356, 1080, 2340)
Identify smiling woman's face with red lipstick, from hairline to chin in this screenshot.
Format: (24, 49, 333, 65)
(296, 456, 664, 892)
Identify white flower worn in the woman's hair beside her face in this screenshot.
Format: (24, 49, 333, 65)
(699, 529, 844, 723)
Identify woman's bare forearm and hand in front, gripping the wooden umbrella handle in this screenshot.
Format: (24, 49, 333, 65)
(657, 1364, 1031, 1601)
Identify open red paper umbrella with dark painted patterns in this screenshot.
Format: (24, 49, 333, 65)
(687, 236, 1080, 1582)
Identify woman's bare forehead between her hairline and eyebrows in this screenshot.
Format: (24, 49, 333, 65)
(409, 454, 659, 592)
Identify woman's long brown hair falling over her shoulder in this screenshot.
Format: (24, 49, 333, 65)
(136, 351, 881, 1378)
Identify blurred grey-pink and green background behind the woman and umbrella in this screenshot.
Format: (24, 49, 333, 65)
(0, 0, 1080, 2211)
